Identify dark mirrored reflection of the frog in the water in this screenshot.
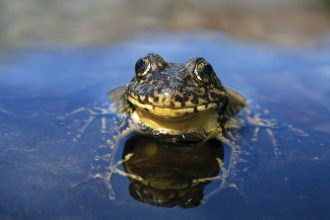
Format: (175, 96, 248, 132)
(120, 135, 224, 208)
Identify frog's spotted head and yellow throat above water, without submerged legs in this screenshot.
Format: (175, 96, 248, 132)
(109, 53, 247, 141)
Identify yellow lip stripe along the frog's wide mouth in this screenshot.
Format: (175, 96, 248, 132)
(128, 95, 217, 119)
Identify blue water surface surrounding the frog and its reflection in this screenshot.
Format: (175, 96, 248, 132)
(0, 33, 330, 219)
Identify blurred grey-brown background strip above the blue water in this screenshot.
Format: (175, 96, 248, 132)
(0, 0, 330, 49)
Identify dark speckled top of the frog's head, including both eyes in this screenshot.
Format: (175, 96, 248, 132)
(127, 53, 228, 112)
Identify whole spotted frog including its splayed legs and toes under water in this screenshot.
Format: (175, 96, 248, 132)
(71, 53, 282, 200)
